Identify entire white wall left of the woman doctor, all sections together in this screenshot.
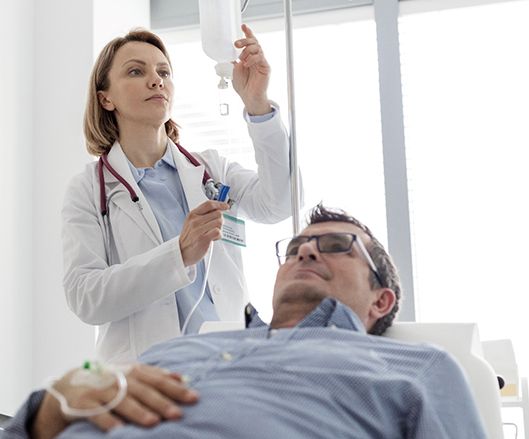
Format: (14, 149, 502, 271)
(0, 0, 149, 414)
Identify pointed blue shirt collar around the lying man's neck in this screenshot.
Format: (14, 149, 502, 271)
(245, 297, 366, 333)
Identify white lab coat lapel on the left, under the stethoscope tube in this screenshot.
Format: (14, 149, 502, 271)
(105, 142, 163, 244)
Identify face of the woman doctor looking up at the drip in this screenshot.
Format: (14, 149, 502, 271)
(98, 41, 173, 131)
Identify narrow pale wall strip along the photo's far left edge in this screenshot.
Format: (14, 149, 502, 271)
(0, 0, 34, 413)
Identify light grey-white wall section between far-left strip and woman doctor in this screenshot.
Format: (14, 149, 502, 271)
(28, 0, 99, 414)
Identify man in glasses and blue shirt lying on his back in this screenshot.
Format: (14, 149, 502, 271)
(4, 205, 486, 439)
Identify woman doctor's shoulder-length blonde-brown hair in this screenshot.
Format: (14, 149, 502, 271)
(84, 29, 178, 156)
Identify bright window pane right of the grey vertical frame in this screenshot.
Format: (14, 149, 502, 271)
(399, 1, 529, 375)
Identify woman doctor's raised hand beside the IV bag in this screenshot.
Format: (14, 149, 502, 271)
(233, 24, 272, 116)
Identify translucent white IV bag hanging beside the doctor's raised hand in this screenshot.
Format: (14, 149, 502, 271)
(198, 0, 241, 88)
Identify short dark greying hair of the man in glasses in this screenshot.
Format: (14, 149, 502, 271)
(308, 203, 401, 335)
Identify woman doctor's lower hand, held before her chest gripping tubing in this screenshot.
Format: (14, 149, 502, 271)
(180, 200, 230, 267)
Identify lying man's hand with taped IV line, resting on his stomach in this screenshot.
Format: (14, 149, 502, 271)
(31, 364, 198, 439)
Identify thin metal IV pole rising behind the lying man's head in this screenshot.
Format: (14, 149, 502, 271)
(284, 0, 300, 236)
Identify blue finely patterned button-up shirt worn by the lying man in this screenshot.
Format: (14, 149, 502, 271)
(2, 299, 486, 439)
